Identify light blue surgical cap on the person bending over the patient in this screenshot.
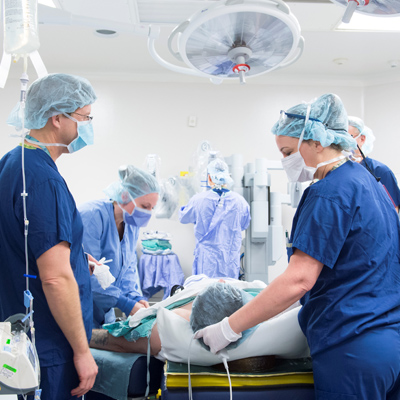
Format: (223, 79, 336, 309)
(104, 165, 160, 204)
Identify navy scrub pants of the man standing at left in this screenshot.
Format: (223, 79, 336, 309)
(18, 361, 81, 400)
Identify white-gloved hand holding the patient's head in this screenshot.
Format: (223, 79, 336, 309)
(194, 317, 242, 354)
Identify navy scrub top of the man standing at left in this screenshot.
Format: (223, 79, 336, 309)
(0, 147, 93, 367)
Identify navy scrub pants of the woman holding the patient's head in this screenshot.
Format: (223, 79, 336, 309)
(313, 326, 400, 400)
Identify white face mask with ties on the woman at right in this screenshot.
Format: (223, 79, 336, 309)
(281, 104, 346, 182)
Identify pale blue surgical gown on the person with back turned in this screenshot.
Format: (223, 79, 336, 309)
(179, 190, 250, 279)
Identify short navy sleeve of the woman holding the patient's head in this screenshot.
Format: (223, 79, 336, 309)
(292, 196, 352, 268)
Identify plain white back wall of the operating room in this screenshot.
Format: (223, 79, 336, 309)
(0, 78, 400, 279)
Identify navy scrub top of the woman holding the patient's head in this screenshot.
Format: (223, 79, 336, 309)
(288, 161, 400, 355)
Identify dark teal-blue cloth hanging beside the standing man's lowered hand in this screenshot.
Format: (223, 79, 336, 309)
(90, 349, 143, 400)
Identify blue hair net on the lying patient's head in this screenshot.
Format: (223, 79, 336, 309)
(190, 282, 256, 349)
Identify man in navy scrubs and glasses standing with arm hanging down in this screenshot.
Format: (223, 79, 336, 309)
(0, 74, 97, 400)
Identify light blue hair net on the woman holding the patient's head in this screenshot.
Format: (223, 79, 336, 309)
(272, 93, 357, 150)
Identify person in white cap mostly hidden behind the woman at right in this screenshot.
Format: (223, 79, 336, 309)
(349, 116, 400, 212)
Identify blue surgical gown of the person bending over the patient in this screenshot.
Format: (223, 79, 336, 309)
(79, 199, 143, 328)
